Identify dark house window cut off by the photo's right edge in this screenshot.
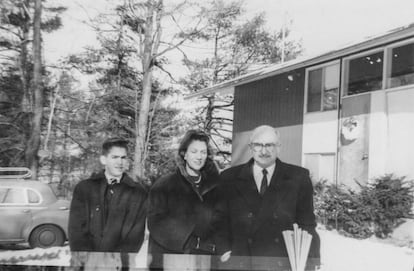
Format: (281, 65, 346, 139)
(389, 43, 414, 87)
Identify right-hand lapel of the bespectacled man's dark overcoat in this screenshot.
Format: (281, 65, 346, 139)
(253, 159, 289, 235)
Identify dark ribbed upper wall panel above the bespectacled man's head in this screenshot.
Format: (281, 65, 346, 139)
(233, 68, 305, 133)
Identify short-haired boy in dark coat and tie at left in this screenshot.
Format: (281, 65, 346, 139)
(68, 138, 147, 253)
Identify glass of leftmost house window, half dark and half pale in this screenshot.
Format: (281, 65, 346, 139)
(307, 64, 339, 112)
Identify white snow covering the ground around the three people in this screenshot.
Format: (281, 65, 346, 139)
(0, 232, 414, 271)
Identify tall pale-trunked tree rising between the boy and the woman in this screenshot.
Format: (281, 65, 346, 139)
(121, 0, 204, 179)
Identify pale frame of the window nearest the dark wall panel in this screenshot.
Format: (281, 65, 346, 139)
(303, 59, 341, 114)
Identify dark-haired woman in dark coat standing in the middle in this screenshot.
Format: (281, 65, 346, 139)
(148, 130, 228, 270)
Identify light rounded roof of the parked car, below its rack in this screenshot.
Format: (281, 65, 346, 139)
(0, 179, 56, 203)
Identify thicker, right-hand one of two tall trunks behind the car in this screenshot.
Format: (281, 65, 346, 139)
(26, 0, 43, 179)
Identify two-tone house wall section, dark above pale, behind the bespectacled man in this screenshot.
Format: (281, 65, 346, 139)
(232, 68, 305, 165)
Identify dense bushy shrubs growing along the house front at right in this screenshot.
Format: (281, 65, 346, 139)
(315, 175, 414, 238)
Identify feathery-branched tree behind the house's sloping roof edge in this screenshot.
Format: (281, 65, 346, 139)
(183, 0, 301, 166)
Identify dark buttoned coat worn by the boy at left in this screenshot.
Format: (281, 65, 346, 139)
(69, 172, 147, 252)
